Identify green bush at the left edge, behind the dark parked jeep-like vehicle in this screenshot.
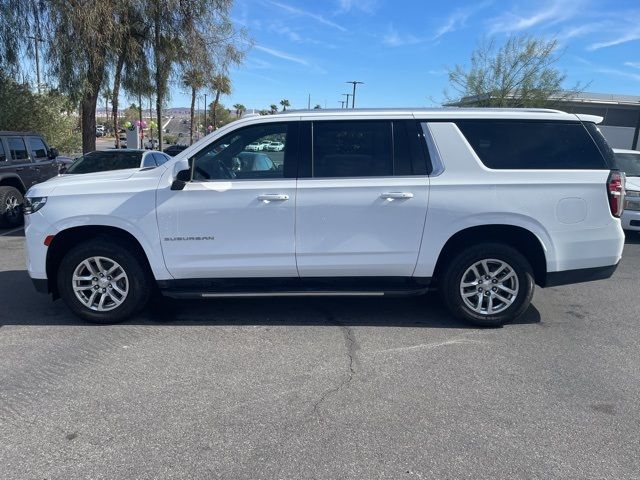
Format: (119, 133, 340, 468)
(0, 72, 82, 155)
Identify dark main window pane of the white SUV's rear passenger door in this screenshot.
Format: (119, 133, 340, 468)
(313, 121, 393, 178)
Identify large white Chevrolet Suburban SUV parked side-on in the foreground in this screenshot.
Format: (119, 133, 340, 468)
(25, 109, 624, 326)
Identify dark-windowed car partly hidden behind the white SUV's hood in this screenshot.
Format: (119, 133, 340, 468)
(62, 149, 171, 175)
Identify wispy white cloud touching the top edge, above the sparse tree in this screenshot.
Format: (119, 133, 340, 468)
(489, 0, 584, 34)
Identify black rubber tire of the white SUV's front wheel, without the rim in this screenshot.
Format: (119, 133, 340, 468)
(57, 239, 153, 324)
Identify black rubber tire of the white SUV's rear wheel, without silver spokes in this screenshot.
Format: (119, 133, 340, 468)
(439, 243, 535, 327)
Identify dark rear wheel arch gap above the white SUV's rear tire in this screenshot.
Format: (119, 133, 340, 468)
(433, 224, 547, 287)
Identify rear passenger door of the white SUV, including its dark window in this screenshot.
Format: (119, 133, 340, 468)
(296, 120, 429, 277)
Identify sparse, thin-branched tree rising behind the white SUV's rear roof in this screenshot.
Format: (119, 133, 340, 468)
(445, 36, 580, 107)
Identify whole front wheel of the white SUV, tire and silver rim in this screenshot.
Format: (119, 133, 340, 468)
(58, 239, 151, 323)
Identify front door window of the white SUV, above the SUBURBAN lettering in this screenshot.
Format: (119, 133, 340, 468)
(193, 123, 289, 180)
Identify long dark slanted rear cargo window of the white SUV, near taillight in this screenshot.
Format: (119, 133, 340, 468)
(457, 120, 608, 170)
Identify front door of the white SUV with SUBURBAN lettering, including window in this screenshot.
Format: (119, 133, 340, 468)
(157, 122, 298, 279)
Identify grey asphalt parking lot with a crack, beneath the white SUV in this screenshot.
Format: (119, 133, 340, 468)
(0, 227, 640, 480)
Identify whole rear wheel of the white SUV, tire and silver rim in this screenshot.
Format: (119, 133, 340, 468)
(440, 243, 535, 327)
